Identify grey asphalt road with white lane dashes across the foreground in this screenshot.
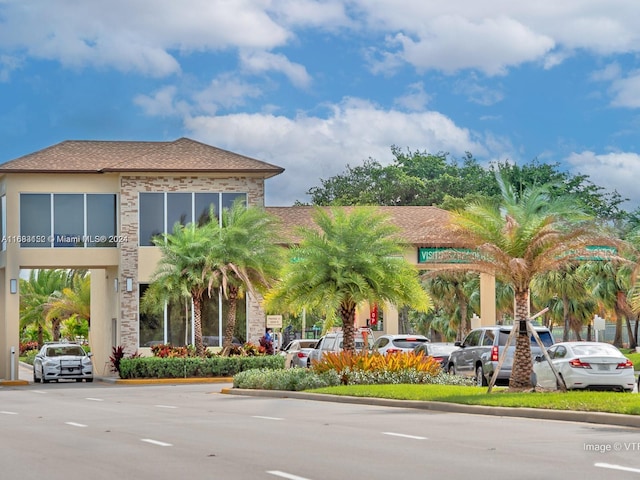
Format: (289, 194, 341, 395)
(0, 382, 640, 480)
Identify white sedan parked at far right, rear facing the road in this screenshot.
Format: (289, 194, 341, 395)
(533, 342, 635, 392)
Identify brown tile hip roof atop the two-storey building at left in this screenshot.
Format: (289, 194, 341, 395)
(0, 138, 284, 178)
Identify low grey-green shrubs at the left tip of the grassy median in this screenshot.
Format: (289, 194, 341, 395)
(233, 368, 340, 391)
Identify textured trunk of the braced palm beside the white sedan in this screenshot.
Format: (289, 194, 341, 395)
(509, 290, 533, 390)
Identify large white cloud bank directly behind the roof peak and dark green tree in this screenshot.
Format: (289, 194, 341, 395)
(185, 99, 487, 206)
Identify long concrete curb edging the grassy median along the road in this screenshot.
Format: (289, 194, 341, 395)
(221, 388, 640, 428)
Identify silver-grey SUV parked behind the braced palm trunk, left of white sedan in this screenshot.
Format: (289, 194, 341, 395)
(447, 325, 554, 386)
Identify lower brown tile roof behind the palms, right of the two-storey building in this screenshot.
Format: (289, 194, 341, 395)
(266, 206, 458, 247)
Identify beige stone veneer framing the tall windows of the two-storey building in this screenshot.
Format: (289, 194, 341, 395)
(119, 176, 265, 354)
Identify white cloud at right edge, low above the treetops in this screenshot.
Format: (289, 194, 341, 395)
(566, 151, 640, 208)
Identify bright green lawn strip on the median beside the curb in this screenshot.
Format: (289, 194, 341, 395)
(310, 385, 640, 415)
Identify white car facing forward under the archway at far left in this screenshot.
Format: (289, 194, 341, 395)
(33, 342, 93, 383)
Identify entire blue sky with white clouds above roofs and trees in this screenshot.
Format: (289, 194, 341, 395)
(0, 0, 640, 210)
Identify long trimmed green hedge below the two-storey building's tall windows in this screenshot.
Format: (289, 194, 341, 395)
(120, 355, 285, 379)
